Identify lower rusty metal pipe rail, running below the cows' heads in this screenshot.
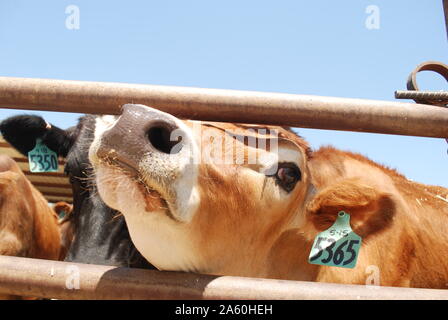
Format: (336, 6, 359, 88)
(0, 256, 448, 300)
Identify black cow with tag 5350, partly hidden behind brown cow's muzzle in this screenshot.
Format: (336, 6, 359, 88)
(0, 115, 154, 269)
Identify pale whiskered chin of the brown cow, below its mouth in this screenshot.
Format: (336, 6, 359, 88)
(95, 165, 174, 219)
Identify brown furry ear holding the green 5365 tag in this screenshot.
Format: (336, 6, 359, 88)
(306, 179, 396, 238)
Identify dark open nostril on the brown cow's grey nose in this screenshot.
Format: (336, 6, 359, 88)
(147, 125, 182, 154)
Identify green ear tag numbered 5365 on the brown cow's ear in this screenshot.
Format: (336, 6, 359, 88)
(308, 211, 362, 268)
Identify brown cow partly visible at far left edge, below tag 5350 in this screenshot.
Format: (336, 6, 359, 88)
(0, 155, 60, 299)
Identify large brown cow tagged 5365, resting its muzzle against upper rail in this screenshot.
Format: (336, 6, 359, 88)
(90, 105, 448, 288)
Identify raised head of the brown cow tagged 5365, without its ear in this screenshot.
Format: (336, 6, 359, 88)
(89, 105, 313, 275)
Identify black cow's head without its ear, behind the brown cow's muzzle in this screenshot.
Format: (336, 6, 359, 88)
(61, 116, 153, 268)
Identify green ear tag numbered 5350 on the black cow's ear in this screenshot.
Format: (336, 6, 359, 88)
(28, 139, 58, 172)
